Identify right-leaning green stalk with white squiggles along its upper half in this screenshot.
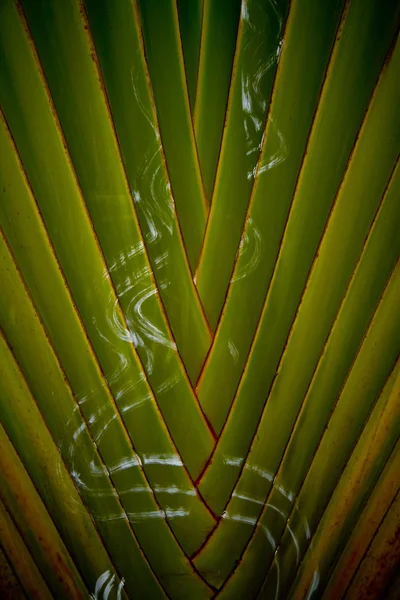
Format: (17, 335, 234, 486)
(196, 0, 288, 330)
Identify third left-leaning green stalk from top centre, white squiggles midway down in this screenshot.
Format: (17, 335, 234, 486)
(85, 0, 211, 382)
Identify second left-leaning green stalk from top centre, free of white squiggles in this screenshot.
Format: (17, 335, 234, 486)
(138, 0, 207, 273)
